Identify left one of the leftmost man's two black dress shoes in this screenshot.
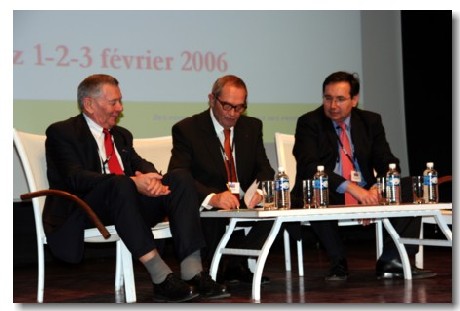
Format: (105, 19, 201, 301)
(153, 273, 200, 302)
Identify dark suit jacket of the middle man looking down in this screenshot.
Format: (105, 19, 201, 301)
(168, 109, 275, 207)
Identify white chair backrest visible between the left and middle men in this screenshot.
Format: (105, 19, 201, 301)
(133, 136, 172, 174)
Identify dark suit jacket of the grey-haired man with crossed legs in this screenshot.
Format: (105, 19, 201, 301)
(43, 114, 160, 262)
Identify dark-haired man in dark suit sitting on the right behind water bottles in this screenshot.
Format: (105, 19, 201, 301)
(292, 71, 434, 281)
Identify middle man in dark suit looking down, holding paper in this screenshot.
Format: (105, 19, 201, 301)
(169, 75, 274, 282)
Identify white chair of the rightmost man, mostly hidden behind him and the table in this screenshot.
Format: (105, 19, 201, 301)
(275, 132, 383, 276)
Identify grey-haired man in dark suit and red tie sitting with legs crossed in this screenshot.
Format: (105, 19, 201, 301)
(43, 75, 229, 302)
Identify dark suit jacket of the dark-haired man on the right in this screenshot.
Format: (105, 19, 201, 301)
(292, 106, 399, 205)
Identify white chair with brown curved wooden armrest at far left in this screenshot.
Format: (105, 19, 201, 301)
(13, 129, 171, 303)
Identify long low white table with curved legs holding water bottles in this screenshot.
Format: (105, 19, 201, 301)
(201, 203, 452, 302)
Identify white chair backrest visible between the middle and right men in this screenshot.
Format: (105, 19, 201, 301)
(275, 132, 297, 190)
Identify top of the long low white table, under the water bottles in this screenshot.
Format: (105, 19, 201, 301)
(201, 203, 452, 218)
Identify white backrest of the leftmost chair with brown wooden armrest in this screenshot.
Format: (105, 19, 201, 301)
(13, 129, 49, 239)
